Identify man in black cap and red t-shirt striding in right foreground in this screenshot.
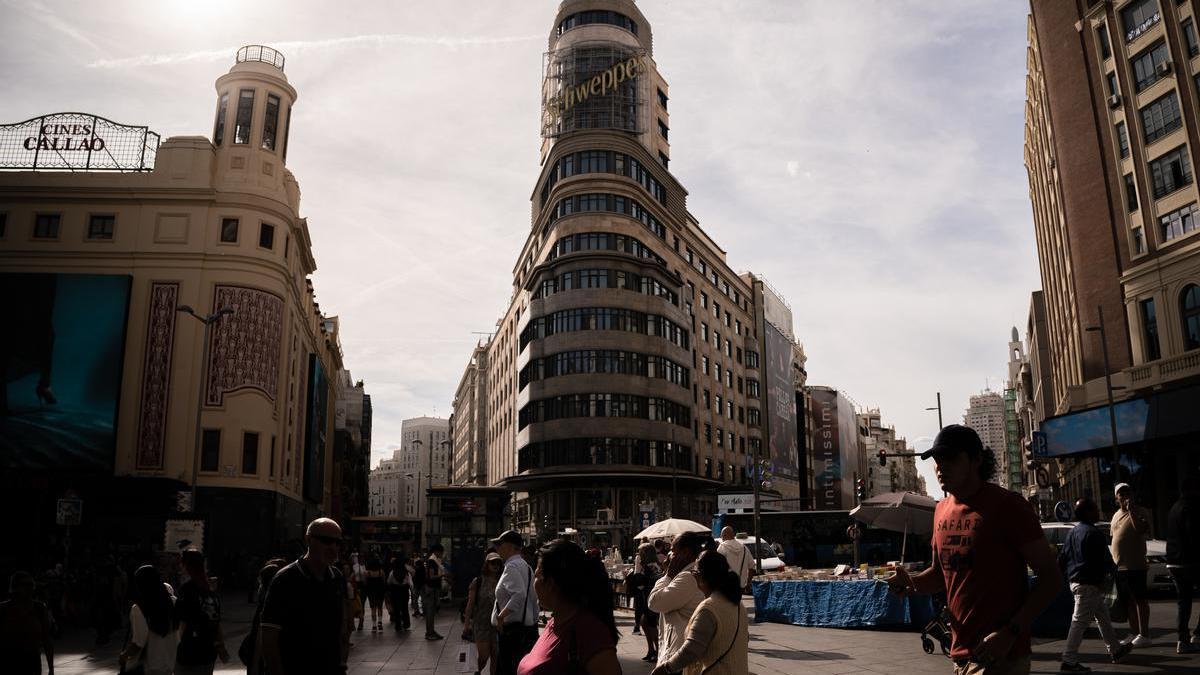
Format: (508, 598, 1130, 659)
(888, 424, 1062, 675)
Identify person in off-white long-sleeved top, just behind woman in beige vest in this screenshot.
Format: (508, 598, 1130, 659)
(647, 532, 708, 665)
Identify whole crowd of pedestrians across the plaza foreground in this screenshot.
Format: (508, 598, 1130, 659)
(0, 425, 1200, 675)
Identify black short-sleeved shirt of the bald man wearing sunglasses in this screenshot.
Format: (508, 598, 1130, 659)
(262, 561, 346, 674)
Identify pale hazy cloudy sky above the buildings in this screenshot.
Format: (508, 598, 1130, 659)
(0, 0, 1039, 492)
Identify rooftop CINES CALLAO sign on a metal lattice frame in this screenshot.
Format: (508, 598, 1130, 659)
(0, 113, 160, 172)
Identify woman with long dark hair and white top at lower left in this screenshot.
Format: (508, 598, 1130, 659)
(120, 565, 179, 675)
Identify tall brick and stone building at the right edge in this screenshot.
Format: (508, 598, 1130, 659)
(1026, 0, 1200, 521)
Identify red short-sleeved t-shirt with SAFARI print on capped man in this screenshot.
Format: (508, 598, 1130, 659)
(932, 483, 1045, 658)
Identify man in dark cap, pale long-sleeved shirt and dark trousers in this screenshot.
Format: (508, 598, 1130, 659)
(492, 530, 538, 675)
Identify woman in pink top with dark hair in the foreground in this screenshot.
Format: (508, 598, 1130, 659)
(517, 539, 620, 675)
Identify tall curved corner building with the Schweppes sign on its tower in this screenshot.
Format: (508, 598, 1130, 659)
(468, 0, 791, 543)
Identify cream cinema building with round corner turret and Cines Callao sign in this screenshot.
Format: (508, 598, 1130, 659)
(0, 47, 365, 554)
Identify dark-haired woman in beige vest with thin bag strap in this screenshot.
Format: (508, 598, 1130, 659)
(650, 550, 750, 675)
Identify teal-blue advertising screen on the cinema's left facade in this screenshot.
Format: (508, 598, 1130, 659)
(0, 274, 130, 471)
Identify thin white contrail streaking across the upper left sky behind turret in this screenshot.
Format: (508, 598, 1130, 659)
(88, 32, 545, 68)
